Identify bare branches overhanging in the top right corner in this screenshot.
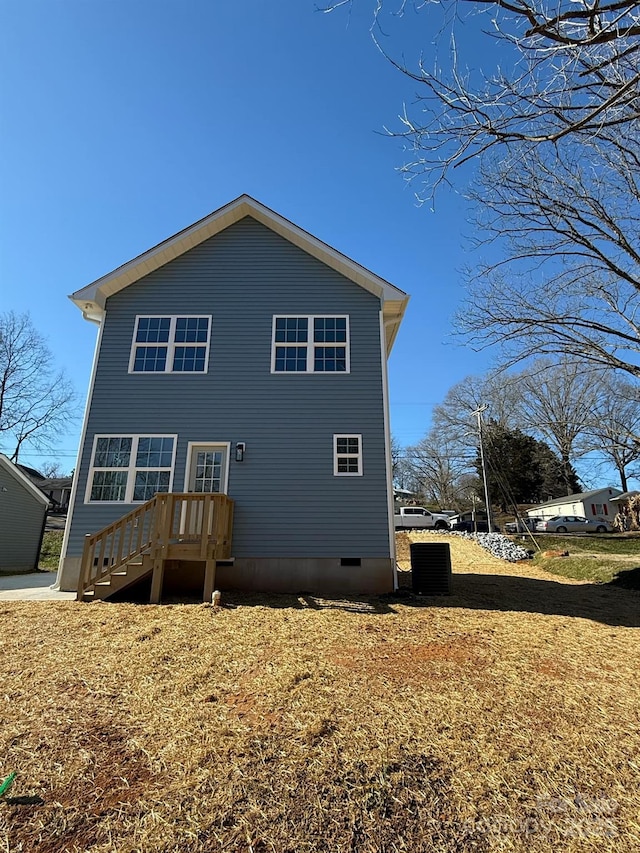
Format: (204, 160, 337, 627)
(326, 0, 640, 183)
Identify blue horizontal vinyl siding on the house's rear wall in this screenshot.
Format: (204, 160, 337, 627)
(68, 217, 389, 557)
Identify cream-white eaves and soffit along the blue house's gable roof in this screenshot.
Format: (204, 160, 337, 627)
(69, 195, 409, 352)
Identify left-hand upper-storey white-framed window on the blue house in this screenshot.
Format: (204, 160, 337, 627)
(129, 316, 211, 373)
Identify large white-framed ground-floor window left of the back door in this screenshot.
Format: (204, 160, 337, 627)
(85, 435, 176, 503)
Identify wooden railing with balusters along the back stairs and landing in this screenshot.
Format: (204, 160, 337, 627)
(78, 492, 233, 600)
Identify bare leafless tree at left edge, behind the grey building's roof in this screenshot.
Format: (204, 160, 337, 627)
(0, 312, 76, 462)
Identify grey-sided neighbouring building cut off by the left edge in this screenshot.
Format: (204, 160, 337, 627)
(0, 453, 48, 572)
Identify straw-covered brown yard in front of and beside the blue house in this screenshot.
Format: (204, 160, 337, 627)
(0, 534, 640, 853)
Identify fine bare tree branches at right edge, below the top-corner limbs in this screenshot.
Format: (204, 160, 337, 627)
(458, 136, 640, 376)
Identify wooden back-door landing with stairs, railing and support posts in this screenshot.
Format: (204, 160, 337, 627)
(78, 493, 233, 603)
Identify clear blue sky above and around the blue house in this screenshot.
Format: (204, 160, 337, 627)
(0, 0, 528, 469)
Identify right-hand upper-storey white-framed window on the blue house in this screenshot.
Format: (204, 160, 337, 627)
(271, 314, 350, 373)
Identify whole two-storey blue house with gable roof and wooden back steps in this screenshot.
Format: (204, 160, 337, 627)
(58, 195, 408, 600)
